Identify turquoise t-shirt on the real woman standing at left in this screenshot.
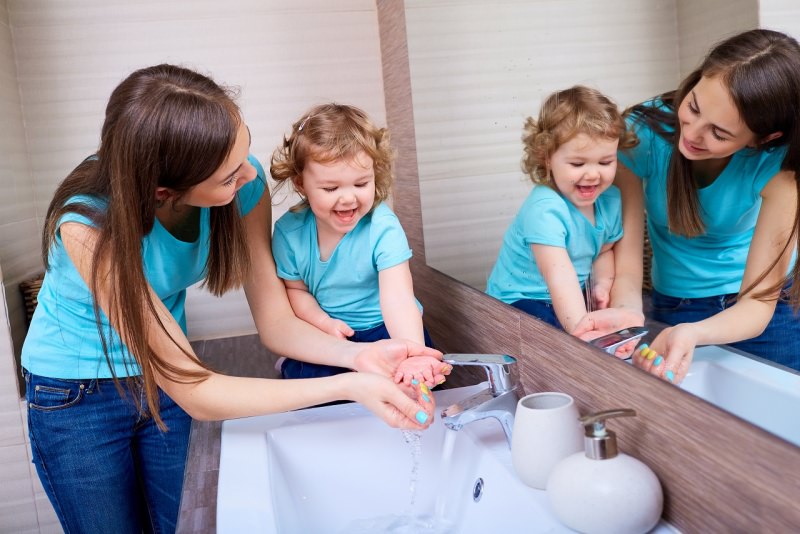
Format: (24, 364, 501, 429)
(22, 156, 266, 379)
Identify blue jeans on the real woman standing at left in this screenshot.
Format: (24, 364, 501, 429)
(23, 370, 191, 534)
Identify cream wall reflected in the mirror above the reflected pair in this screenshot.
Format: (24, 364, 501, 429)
(405, 0, 800, 446)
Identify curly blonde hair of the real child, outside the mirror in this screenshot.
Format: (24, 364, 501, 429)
(269, 103, 394, 211)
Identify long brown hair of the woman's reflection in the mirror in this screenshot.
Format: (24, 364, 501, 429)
(626, 29, 800, 309)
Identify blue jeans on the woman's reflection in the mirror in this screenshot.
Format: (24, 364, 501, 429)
(651, 289, 800, 371)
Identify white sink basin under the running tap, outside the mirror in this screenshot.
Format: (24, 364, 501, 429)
(217, 384, 675, 534)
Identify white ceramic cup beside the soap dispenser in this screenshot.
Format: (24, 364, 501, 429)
(511, 392, 583, 489)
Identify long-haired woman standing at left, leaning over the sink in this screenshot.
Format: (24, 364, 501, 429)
(22, 65, 440, 533)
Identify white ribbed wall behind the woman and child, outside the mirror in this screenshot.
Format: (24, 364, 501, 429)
(8, 0, 385, 339)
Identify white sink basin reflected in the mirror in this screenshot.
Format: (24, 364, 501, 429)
(681, 345, 800, 445)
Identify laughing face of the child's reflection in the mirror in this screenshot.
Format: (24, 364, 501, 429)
(548, 133, 619, 213)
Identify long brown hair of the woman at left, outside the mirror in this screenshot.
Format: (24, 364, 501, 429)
(42, 65, 249, 428)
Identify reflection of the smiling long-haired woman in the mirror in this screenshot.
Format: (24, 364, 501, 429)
(581, 29, 800, 383)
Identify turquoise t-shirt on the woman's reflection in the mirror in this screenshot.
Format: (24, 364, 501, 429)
(619, 102, 786, 298)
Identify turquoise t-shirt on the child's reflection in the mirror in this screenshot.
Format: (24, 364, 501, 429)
(486, 185, 622, 304)
